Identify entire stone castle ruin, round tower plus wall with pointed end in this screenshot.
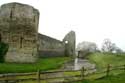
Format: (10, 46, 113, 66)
(0, 2, 75, 63)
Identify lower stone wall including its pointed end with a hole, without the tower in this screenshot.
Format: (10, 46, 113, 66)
(38, 31, 75, 57)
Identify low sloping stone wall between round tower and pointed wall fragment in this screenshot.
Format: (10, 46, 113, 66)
(38, 34, 65, 57)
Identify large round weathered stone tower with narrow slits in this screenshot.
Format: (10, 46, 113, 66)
(0, 3, 39, 63)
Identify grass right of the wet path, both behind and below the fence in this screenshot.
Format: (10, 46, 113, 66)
(76, 53, 125, 83)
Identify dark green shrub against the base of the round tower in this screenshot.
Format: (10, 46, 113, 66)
(0, 42, 9, 62)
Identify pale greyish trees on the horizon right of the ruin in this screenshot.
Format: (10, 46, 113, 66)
(76, 38, 124, 54)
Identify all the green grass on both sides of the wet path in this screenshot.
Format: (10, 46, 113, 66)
(0, 53, 125, 83)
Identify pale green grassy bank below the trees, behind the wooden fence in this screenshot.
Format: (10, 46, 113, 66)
(87, 53, 125, 70)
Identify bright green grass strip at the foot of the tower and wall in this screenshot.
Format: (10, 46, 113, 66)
(0, 57, 70, 73)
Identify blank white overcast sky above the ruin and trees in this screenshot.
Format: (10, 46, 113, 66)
(0, 0, 125, 50)
